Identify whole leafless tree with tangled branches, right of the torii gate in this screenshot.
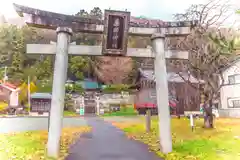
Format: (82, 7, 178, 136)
(172, 0, 238, 128)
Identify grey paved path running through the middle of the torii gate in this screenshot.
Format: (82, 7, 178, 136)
(65, 117, 162, 160)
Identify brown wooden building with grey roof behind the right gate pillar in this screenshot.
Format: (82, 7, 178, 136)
(135, 68, 200, 115)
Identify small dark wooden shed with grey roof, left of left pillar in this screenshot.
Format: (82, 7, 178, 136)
(30, 93, 52, 116)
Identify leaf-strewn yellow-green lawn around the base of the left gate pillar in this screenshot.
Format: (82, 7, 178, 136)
(0, 126, 90, 160)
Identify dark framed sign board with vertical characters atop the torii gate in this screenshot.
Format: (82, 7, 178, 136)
(102, 10, 130, 56)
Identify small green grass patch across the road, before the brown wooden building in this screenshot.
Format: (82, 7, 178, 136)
(103, 105, 137, 116)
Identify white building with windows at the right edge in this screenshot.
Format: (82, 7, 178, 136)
(219, 60, 240, 118)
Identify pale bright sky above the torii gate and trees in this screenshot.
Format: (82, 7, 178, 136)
(0, 0, 240, 20)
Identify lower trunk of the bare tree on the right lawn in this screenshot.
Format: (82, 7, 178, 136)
(204, 100, 213, 128)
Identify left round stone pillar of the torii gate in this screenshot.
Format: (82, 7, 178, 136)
(47, 27, 72, 157)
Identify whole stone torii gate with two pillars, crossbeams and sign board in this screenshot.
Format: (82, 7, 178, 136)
(14, 4, 196, 157)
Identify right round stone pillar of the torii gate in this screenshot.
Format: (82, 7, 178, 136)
(151, 33, 172, 154)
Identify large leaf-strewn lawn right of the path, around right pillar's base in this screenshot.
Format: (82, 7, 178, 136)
(113, 117, 240, 160)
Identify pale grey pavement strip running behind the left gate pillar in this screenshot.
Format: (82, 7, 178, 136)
(0, 117, 86, 133)
